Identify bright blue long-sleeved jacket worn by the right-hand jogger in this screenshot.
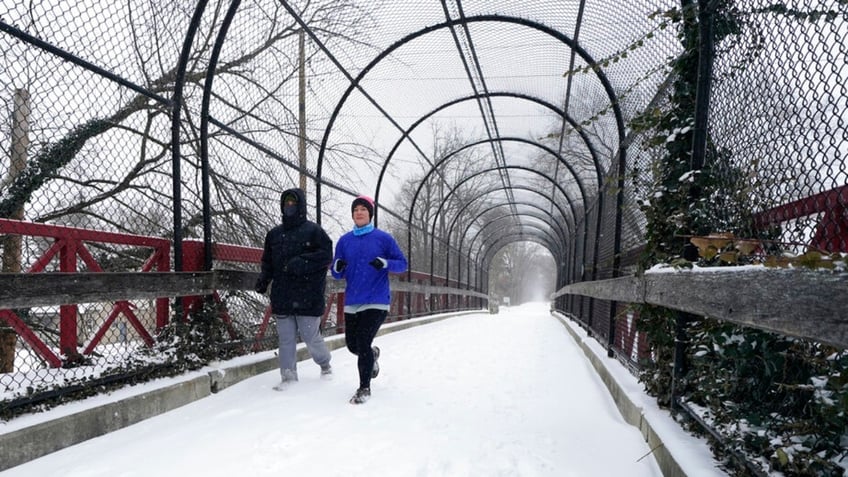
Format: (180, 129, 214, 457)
(330, 228, 407, 306)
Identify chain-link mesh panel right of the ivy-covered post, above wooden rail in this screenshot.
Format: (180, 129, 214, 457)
(710, 2, 848, 252)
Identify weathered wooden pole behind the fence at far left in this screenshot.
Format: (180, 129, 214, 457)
(0, 89, 30, 373)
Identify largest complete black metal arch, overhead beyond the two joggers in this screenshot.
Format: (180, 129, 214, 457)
(310, 13, 625, 219)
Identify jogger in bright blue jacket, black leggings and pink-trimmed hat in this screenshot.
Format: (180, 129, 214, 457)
(331, 195, 407, 404)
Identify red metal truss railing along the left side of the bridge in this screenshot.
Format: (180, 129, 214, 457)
(0, 219, 484, 367)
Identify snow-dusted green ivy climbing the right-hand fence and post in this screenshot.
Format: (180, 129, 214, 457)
(630, 0, 848, 476)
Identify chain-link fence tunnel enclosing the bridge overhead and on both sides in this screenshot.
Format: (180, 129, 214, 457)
(0, 0, 848, 472)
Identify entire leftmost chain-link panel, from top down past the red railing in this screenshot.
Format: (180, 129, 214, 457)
(0, 2, 187, 414)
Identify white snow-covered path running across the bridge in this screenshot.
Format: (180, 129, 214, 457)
(0, 303, 726, 477)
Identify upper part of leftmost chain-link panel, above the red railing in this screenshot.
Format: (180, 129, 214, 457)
(0, 2, 181, 232)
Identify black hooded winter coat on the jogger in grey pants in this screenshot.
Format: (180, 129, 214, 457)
(256, 189, 333, 316)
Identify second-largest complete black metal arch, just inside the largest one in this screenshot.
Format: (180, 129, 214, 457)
(374, 92, 603, 224)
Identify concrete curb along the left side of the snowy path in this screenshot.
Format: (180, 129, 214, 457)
(0, 310, 470, 472)
